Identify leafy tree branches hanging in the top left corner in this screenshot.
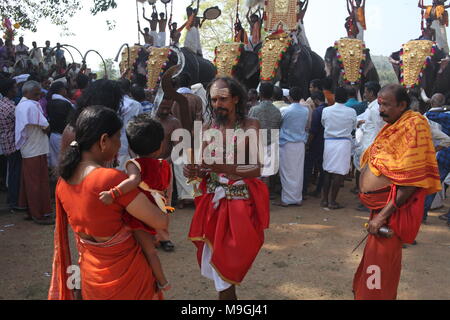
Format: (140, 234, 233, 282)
(0, 0, 117, 32)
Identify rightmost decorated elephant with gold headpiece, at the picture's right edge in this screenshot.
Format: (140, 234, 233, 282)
(390, 40, 450, 102)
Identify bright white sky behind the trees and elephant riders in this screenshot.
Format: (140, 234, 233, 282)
(15, 0, 432, 70)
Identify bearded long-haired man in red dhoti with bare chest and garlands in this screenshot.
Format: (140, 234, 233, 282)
(184, 78, 269, 300)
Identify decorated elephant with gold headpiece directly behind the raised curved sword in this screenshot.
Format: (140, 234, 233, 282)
(121, 46, 216, 89)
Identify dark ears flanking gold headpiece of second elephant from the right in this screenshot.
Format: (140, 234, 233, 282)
(325, 43, 380, 96)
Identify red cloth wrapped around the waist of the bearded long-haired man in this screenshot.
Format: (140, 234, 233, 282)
(189, 178, 269, 284)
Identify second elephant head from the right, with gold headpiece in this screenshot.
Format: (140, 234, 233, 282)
(325, 38, 380, 96)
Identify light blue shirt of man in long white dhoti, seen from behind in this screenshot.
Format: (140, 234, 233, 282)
(280, 103, 309, 146)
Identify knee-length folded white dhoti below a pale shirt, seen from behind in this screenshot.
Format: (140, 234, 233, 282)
(323, 138, 352, 176)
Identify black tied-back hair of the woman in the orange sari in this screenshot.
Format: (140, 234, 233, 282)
(59, 106, 123, 181)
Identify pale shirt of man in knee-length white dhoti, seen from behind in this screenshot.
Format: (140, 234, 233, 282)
(322, 103, 356, 139)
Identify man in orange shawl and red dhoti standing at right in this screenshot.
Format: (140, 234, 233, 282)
(353, 85, 441, 300)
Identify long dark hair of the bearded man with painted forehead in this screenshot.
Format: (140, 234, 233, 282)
(206, 77, 248, 122)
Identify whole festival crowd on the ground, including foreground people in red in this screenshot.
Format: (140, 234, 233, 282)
(0, 1, 450, 300)
